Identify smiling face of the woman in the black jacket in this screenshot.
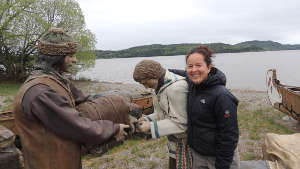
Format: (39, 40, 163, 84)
(186, 53, 211, 84)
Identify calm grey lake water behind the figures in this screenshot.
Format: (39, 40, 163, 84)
(79, 50, 300, 90)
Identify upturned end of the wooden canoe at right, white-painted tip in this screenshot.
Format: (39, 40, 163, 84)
(266, 69, 300, 123)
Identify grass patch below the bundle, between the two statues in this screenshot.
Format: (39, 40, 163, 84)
(83, 138, 168, 169)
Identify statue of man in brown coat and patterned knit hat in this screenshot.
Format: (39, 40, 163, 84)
(14, 28, 129, 169)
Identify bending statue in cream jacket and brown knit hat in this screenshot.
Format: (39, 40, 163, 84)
(133, 60, 191, 169)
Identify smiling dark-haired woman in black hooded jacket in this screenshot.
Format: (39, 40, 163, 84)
(171, 46, 239, 169)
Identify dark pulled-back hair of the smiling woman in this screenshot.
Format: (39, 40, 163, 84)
(185, 46, 214, 66)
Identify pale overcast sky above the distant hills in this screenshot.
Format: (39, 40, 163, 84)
(76, 0, 300, 50)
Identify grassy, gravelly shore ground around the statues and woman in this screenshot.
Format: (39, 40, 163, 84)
(0, 81, 300, 169)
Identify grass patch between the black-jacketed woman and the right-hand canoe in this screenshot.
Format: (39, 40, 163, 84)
(238, 102, 296, 160)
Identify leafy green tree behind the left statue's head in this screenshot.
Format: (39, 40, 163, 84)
(0, 0, 96, 80)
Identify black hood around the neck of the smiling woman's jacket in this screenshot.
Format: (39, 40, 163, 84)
(189, 67, 226, 88)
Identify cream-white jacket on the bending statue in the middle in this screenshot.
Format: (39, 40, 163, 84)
(146, 71, 188, 158)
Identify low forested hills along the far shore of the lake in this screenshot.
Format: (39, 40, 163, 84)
(96, 40, 300, 59)
